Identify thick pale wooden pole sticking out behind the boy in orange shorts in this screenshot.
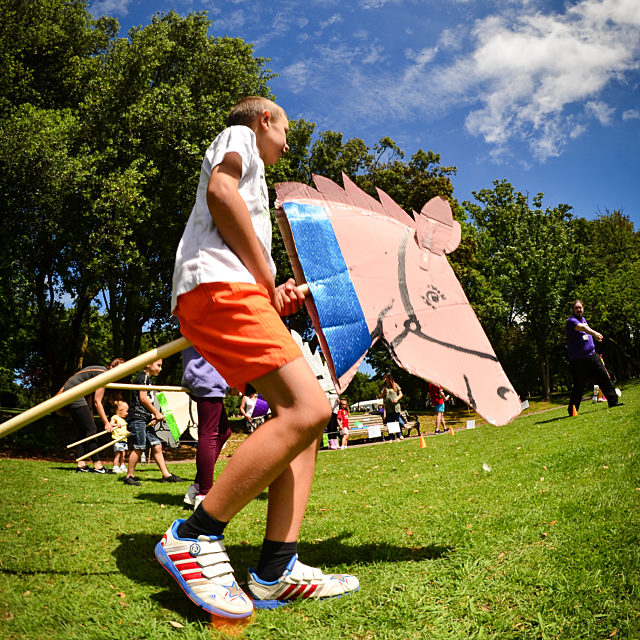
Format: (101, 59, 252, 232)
(0, 337, 191, 438)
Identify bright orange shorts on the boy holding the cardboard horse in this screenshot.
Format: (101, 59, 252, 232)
(175, 282, 302, 393)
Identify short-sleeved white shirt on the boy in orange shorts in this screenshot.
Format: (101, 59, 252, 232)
(171, 125, 276, 312)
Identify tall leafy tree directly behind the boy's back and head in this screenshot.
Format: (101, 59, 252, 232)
(80, 12, 272, 357)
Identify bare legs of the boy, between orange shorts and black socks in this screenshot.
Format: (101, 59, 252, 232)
(202, 358, 331, 524)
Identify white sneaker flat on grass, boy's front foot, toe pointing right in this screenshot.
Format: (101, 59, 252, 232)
(247, 554, 360, 609)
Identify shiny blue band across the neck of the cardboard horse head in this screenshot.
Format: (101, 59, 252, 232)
(283, 202, 371, 378)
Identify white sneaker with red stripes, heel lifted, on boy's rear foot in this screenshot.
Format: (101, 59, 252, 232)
(155, 520, 253, 618)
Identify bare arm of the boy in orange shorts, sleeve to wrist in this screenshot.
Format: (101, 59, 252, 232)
(207, 152, 281, 312)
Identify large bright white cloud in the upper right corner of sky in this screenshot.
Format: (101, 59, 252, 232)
(360, 0, 640, 161)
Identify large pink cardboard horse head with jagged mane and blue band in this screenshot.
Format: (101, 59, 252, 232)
(276, 175, 520, 424)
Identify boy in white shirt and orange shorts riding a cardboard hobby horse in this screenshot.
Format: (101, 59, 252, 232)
(156, 96, 360, 618)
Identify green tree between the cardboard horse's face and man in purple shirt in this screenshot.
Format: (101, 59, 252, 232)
(463, 180, 576, 398)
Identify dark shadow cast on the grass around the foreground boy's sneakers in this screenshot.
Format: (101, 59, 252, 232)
(113, 532, 453, 620)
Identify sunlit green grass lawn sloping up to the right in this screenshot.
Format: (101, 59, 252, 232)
(0, 383, 640, 640)
